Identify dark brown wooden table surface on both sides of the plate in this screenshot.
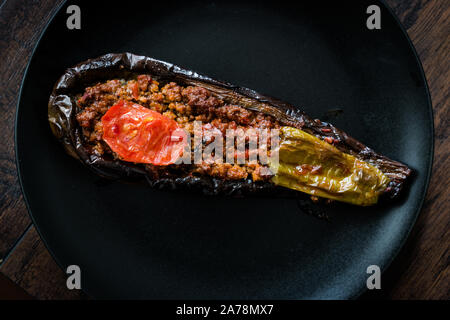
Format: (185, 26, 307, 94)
(0, 0, 450, 299)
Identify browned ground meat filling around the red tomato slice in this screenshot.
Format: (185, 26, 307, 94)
(76, 74, 279, 181)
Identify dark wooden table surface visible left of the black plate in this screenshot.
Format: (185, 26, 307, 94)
(0, 0, 82, 299)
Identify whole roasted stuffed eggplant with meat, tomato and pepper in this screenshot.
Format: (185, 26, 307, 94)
(48, 53, 411, 206)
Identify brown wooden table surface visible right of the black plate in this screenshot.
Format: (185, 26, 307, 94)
(363, 0, 450, 299)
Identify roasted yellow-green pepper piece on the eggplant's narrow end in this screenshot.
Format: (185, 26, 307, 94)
(271, 127, 389, 206)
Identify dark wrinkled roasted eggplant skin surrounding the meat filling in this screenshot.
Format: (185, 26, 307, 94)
(48, 53, 412, 198)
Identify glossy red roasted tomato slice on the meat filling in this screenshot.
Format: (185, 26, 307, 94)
(102, 100, 187, 165)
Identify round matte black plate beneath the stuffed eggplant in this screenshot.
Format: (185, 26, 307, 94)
(16, 0, 433, 299)
